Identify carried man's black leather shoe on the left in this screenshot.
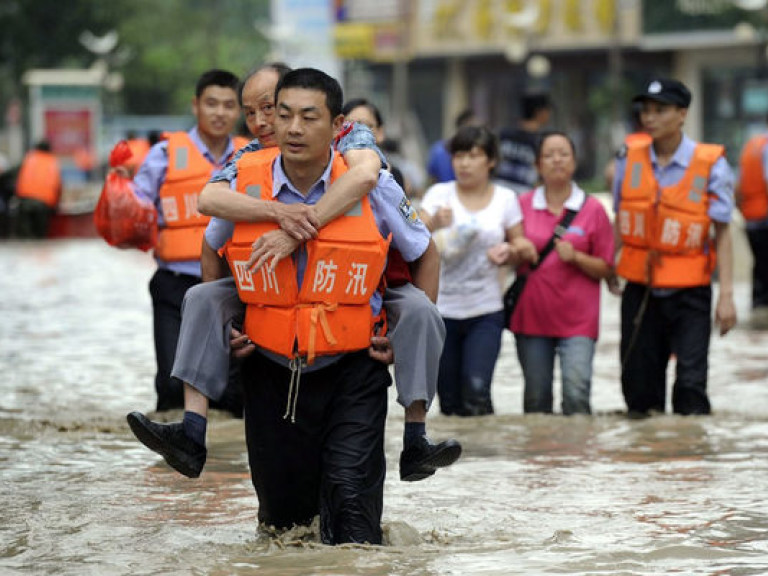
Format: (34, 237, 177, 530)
(127, 412, 208, 478)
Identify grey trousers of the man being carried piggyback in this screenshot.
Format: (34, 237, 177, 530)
(171, 277, 445, 409)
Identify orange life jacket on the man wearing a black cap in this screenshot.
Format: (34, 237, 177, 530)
(616, 134, 724, 288)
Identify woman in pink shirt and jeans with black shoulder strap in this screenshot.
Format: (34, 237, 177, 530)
(511, 132, 614, 414)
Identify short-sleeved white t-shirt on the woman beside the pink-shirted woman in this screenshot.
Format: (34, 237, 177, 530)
(421, 182, 523, 320)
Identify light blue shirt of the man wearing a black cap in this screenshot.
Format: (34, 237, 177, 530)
(612, 134, 733, 223)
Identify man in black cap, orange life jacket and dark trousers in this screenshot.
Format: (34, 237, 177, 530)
(613, 78, 736, 416)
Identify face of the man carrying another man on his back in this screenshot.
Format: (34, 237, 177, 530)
(275, 88, 344, 165)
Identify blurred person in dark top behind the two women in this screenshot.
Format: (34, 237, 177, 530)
(496, 94, 552, 193)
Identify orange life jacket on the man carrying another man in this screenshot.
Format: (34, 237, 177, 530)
(226, 148, 389, 364)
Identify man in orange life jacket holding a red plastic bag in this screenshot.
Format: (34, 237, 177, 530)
(128, 70, 242, 414)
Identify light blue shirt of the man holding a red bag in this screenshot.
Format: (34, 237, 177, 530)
(133, 127, 235, 277)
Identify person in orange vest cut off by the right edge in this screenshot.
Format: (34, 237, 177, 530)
(736, 121, 768, 309)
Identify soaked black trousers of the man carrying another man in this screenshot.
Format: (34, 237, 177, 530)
(243, 350, 392, 544)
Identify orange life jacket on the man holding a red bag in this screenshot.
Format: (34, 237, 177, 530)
(155, 132, 214, 261)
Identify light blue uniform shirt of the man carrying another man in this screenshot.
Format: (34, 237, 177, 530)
(222, 148, 430, 371)
